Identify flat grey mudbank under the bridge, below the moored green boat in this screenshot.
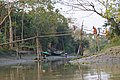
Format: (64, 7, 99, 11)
(0, 55, 75, 66)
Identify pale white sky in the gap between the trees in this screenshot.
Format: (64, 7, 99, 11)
(55, 0, 106, 33)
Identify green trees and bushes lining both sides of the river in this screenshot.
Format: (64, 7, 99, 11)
(0, 0, 120, 56)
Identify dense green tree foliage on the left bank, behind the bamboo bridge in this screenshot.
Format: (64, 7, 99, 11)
(0, 0, 88, 53)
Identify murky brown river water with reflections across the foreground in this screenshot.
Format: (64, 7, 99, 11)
(0, 62, 120, 80)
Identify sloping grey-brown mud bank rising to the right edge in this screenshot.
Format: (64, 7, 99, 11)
(70, 46, 120, 64)
